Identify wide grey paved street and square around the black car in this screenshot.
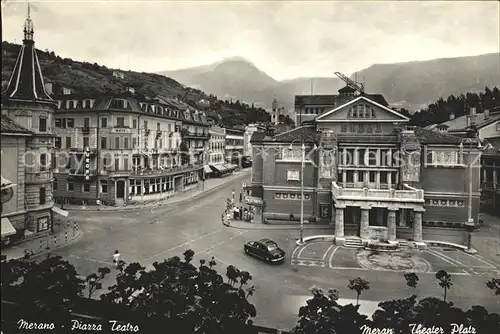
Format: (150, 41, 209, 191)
(40, 178, 500, 329)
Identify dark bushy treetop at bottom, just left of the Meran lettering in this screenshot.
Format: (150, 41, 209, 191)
(293, 287, 367, 334)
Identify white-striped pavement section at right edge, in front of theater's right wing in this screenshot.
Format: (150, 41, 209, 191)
(421, 247, 500, 276)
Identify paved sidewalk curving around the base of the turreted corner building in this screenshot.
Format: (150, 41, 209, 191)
(1, 222, 83, 261)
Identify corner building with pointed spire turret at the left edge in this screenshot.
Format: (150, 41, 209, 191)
(1, 14, 67, 243)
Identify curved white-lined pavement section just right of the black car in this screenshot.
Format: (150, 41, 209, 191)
(291, 241, 337, 268)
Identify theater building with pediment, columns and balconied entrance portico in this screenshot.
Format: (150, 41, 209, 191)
(251, 89, 479, 247)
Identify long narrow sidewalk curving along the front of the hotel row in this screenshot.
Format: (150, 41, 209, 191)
(64, 170, 250, 211)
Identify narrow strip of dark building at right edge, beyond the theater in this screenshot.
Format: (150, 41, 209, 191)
(481, 147, 500, 216)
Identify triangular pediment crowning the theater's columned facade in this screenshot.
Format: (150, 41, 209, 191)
(316, 96, 409, 122)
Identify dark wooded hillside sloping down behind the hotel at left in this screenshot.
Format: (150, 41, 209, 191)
(2, 42, 269, 126)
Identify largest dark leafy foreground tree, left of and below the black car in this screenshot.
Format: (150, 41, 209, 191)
(101, 250, 256, 334)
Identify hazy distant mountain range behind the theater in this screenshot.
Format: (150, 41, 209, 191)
(160, 53, 500, 110)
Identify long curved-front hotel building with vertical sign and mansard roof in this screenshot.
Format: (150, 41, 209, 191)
(54, 94, 208, 205)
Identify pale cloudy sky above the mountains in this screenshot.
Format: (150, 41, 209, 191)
(2, 0, 500, 80)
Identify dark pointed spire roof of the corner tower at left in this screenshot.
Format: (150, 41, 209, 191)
(2, 17, 53, 102)
